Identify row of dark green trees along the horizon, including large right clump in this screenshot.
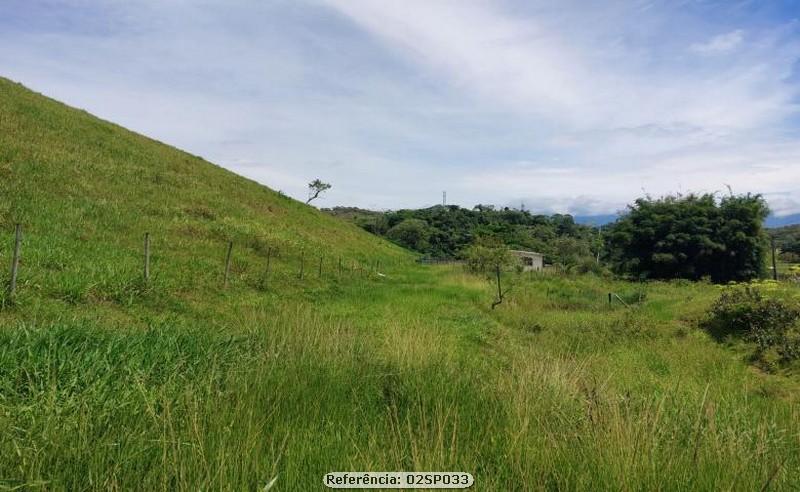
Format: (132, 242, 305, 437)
(327, 193, 769, 282)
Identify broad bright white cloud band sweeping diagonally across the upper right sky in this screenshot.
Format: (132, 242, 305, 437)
(328, 0, 800, 129)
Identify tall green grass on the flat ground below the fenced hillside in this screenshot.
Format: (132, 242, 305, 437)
(0, 269, 800, 490)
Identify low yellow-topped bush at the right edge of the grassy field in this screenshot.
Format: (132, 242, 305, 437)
(706, 286, 800, 362)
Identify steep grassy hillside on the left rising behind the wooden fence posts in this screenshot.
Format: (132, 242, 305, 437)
(0, 79, 407, 312)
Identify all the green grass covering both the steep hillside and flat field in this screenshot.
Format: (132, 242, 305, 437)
(0, 81, 800, 491)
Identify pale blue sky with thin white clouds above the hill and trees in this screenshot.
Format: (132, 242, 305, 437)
(0, 0, 800, 216)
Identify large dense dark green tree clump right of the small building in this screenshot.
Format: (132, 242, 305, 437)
(608, 194, 768, 282)
